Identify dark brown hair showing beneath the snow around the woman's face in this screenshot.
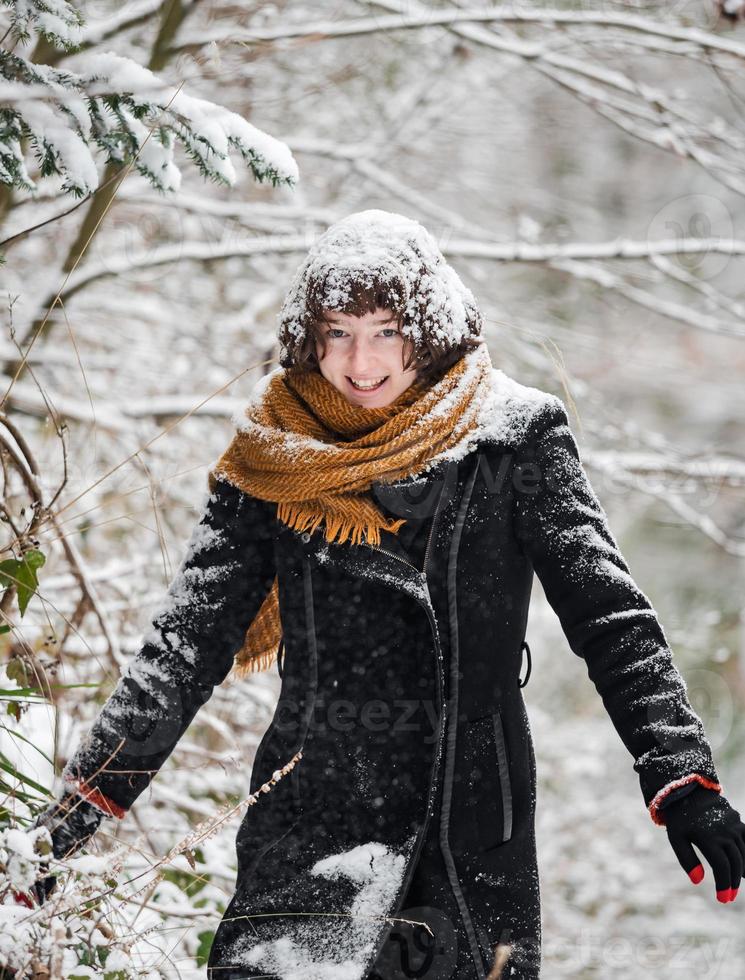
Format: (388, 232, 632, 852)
(279, 276, 483, 386)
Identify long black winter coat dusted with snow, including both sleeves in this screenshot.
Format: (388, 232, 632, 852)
(66, 375, 718, 980)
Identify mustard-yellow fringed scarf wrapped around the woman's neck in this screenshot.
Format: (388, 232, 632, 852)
(209, 344, 492, 678)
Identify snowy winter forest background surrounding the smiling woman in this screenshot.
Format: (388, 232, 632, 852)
(0, 0, 745, 980)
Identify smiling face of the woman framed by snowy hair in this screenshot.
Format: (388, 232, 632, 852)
(316, 307, 416, 408)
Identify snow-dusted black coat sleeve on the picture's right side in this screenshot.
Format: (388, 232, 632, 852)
(513, 395, 721, 826)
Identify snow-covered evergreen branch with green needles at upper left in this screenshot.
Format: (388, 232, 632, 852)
(0, 27, 298, 197)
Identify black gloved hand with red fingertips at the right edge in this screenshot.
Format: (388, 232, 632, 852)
(660, 783, 745, 902)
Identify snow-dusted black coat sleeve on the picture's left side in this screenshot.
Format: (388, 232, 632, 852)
(62, 478, 276, 819)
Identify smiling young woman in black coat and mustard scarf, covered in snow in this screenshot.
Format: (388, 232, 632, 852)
(29, 211, 745, 980)
